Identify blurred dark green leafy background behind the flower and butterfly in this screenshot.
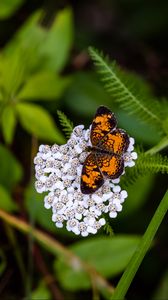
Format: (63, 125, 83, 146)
(0, 0, 168, 300)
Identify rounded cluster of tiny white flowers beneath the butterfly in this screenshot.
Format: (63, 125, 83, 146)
(34, 125, 137, 236)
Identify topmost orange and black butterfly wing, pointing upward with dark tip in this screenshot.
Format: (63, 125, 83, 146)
(90, 106, 117, 146)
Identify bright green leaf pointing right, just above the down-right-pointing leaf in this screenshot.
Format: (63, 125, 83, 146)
(17, 71, 70, 100)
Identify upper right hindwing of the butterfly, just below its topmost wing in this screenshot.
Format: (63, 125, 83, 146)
(97, 129, 129, 155)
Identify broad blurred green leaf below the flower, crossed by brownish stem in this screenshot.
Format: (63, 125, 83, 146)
(55, 235, 140, 290)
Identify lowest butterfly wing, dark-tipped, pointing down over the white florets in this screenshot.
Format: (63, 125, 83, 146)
(81, 153, 104, 194)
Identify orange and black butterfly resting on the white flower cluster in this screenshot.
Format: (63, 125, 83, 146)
(80, 106, 129, 194)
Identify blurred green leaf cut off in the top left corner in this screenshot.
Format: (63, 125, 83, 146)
(0, 0, 25, 19)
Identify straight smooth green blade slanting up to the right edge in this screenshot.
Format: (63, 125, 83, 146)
(111, 190, 168, 300)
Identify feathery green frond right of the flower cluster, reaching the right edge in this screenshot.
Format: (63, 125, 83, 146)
(122, 152, 168, 186)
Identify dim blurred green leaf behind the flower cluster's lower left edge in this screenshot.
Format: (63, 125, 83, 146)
(24, 183, 56, 232)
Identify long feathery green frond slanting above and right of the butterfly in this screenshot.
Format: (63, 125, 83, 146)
(89, 47, 162, 130)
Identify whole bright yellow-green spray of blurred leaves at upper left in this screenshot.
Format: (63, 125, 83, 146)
(0, 8, 73, 144)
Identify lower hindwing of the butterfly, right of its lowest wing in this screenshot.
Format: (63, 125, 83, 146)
(96, 153, 124, 179)
